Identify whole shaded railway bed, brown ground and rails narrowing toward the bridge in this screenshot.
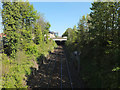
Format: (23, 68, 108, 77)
(27, 45, 83, 90)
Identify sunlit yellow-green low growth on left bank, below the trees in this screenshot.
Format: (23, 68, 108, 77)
(0, 41, 57, 88)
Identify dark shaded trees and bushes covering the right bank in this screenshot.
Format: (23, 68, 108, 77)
(63, 1, 120, 88)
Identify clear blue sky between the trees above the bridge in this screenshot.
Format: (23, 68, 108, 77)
(30, 2, 92, 36)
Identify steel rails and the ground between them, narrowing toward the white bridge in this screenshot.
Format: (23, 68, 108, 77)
(45, 46, 73, 89)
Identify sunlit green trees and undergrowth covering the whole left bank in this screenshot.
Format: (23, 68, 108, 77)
(2, 0, 57, 88)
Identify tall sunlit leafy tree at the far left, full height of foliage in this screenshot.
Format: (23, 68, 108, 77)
(2, 1, 21, 57)
